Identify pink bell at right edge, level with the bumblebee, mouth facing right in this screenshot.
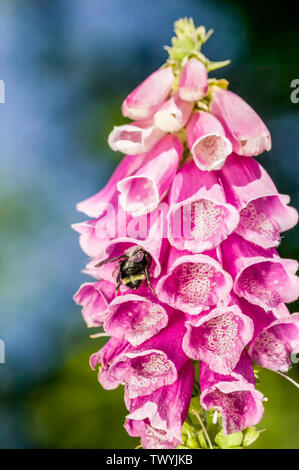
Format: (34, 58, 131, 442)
(222, 234, 299, 310)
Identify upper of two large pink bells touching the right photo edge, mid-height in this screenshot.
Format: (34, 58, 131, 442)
(220, 155, 298, 248)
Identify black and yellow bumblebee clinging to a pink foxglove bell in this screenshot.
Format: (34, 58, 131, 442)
(95, 246, 156, 295)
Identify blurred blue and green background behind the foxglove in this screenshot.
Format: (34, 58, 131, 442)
(0, 0, 299, 449)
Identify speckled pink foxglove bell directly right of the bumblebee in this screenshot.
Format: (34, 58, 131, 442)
(156, 247, 232, 315)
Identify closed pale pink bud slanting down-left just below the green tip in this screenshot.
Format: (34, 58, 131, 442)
(122, 67, 174, 120)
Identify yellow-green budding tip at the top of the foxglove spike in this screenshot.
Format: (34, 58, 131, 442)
(165, 18, 230, 71)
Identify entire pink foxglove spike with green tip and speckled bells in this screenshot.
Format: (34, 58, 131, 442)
(73, 20, 299, 448)
